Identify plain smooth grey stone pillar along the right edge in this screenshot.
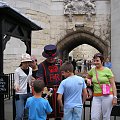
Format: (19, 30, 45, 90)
(111, 0, 120, 82)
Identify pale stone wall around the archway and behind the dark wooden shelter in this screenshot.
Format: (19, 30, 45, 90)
(2, 0, 110, 73)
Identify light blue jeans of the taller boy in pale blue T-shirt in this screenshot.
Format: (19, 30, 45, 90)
(64, 107, 82, 120)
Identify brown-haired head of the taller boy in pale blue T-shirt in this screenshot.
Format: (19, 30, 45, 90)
(60, 61, 73, 77)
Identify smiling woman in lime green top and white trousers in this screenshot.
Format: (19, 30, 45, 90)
(87, 53, 117, 120)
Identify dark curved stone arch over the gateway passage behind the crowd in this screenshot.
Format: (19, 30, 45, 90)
(57, 29, 110, 59)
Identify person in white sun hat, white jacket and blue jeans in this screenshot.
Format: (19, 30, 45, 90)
(14, 53, 32, 120)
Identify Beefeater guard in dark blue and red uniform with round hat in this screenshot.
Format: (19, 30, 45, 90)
(36, 44, 62, 119)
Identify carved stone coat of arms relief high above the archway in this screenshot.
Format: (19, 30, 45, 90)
(64, 0, 96, 21)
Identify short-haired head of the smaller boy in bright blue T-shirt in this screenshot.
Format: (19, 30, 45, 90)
(33, 80, 45, 93)
